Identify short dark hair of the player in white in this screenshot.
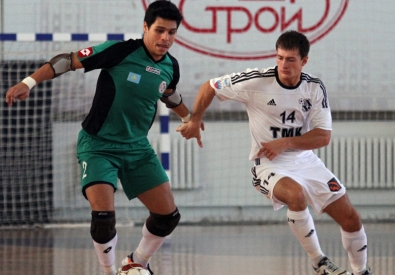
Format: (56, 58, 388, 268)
(276, 30, 310, 58)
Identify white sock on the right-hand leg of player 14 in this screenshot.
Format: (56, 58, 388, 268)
(341, 226, 368, 274)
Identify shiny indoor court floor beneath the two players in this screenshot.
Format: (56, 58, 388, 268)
(0, 222, 395, 275)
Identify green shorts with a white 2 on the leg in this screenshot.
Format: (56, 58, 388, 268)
(77, 130, 169, 200)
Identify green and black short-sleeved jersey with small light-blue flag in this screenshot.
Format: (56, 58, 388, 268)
(76, 39, 180, 143)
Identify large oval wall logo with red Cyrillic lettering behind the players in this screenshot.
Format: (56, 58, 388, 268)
(142, 0, 350, 60)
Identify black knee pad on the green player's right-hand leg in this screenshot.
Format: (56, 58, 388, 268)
(145, 209, 181, 237)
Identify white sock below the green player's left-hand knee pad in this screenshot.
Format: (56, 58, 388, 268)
(93, 235, 118, 274)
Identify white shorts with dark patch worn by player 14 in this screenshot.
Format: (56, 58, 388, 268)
(251, 155, 346, 214)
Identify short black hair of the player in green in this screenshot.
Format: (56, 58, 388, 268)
(144, 0, 183, 28)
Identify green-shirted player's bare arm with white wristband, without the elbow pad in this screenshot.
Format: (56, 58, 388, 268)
(5, 53, 83, 106)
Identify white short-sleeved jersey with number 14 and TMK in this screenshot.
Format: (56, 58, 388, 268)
(210, 67, 332, 161)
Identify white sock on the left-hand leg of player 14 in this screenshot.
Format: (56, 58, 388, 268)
(287, 208, 324, 268)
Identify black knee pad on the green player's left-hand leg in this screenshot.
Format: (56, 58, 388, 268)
(91, 211, 117, 244)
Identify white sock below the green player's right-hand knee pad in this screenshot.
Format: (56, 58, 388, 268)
(133, 223, 166, 266)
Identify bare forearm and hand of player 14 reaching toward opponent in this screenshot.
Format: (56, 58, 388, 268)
(177, 81, 215, 147)
